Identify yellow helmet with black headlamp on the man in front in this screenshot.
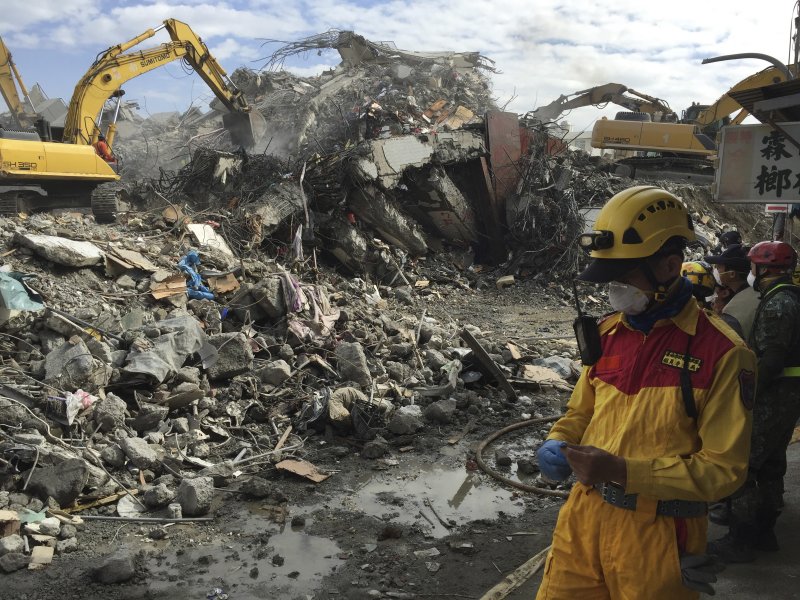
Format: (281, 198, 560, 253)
(578, 185, 697, 283)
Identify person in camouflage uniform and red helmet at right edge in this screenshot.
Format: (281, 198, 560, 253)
(708, 242, 800, 562)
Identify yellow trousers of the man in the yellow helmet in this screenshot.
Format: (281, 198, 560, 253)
(536, 484, 708, 600)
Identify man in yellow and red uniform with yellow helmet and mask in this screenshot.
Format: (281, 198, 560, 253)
(537, 186, 756, 600)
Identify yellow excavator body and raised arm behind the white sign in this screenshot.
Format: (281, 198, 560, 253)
(592, 65, 796, 170)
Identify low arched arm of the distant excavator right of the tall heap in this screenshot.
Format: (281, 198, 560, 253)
(523, 83, 678, 123)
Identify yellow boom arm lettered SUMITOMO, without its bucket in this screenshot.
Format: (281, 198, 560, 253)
(63, 19, 255, 144)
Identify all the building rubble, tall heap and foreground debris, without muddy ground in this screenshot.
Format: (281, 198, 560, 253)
(0, 32, 768, 580)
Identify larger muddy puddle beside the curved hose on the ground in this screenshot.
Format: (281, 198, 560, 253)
(326, 465, 524, 538)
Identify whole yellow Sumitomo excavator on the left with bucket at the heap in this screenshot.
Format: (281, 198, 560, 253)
(0, 19, 266, 222)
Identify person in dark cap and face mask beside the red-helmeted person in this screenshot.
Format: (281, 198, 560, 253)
(706, 244, 759, 341)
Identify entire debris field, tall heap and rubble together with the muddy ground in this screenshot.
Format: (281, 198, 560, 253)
(0, 31, 767, 599)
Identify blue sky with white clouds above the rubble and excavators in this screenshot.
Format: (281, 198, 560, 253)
(0, 0, 794, 129)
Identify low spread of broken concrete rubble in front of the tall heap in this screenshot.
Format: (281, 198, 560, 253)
(0, 200, 588, 571)
